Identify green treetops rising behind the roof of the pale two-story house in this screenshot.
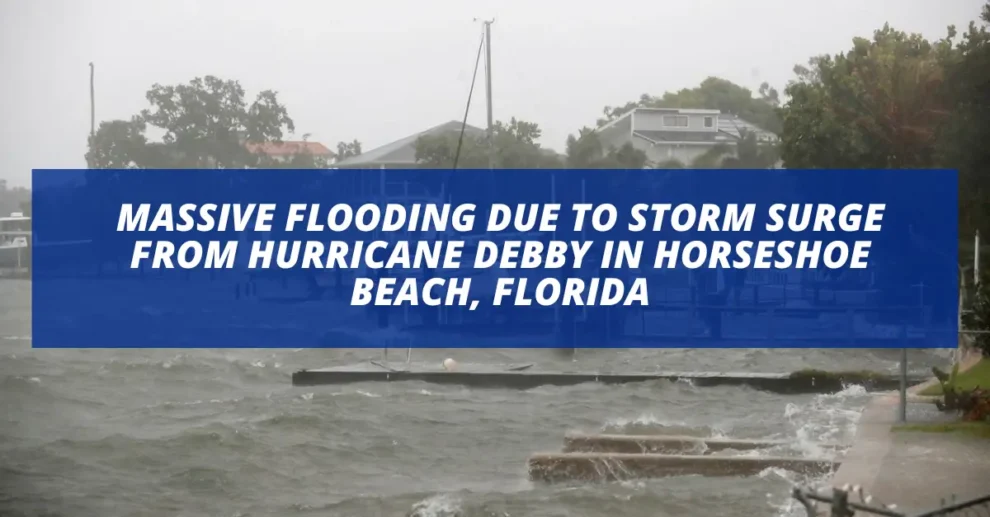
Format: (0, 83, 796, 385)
(598, 77, 780, 133)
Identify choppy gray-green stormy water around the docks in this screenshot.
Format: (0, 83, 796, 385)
(0, 281, 946, 517)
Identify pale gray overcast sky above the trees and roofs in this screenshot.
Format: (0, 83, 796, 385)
(0, 0, 983, 185)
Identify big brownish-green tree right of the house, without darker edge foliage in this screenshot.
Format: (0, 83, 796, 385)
(781, 25, 952, 168)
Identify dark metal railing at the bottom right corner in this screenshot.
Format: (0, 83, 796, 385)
(792, 486, 990, 517)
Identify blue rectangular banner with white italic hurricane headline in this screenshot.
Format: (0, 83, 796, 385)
(31, 169, 959, 348)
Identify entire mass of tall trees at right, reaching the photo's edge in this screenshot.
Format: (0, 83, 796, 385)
(780, 3, 990, 235)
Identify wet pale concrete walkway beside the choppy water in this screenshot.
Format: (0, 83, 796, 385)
(832, 352, 990, 514)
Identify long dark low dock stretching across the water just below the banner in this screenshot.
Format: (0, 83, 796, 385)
(292, 361, 920, 394)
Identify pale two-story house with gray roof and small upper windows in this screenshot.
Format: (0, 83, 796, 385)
(597, 108, 778, 166)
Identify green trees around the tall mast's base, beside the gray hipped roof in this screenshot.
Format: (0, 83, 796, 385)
(416, 118, 561, 169)
